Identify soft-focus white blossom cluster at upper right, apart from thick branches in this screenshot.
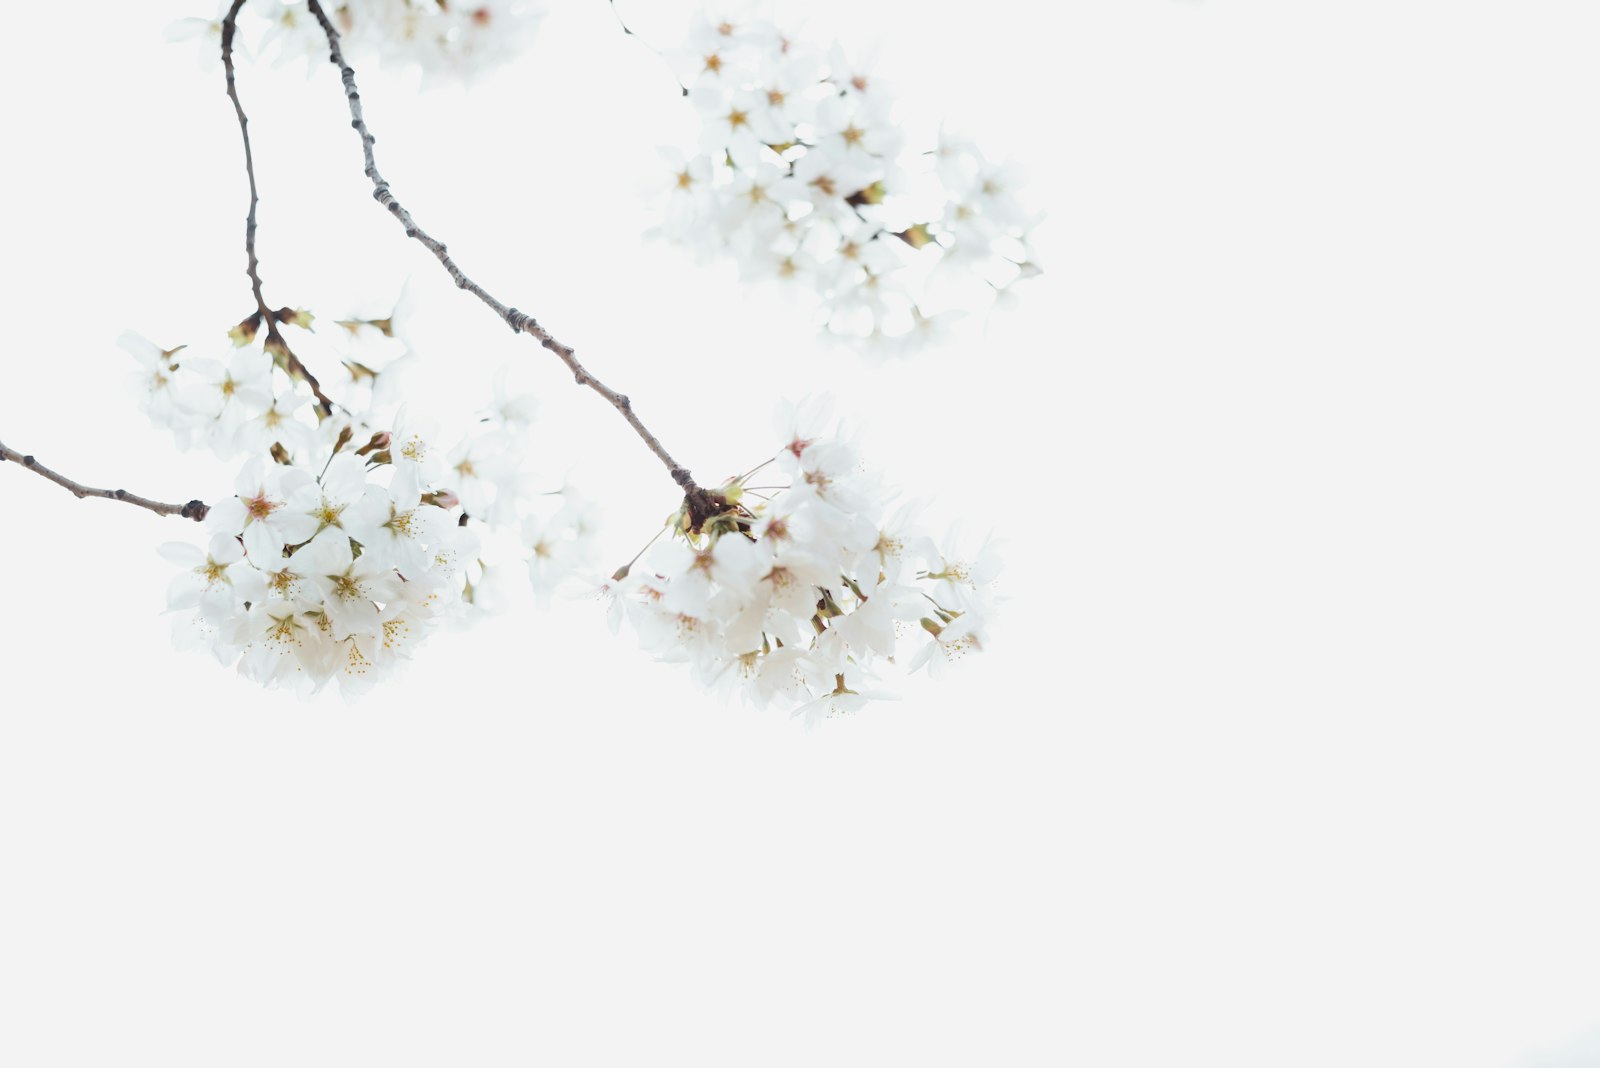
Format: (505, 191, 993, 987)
(658, 5, 1038, 355)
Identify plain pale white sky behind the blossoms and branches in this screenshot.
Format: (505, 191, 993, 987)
(0, 0, 1600, 1068)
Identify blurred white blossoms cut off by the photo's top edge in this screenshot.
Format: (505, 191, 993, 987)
(168, 0, 546, 82)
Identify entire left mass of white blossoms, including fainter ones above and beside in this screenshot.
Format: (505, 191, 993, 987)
(122, 303, 594, 694)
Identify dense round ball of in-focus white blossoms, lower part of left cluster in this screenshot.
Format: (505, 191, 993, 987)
(162, 438, 477, 691)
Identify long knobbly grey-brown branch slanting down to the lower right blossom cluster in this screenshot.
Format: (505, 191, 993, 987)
(309, 0, 722, 528)
